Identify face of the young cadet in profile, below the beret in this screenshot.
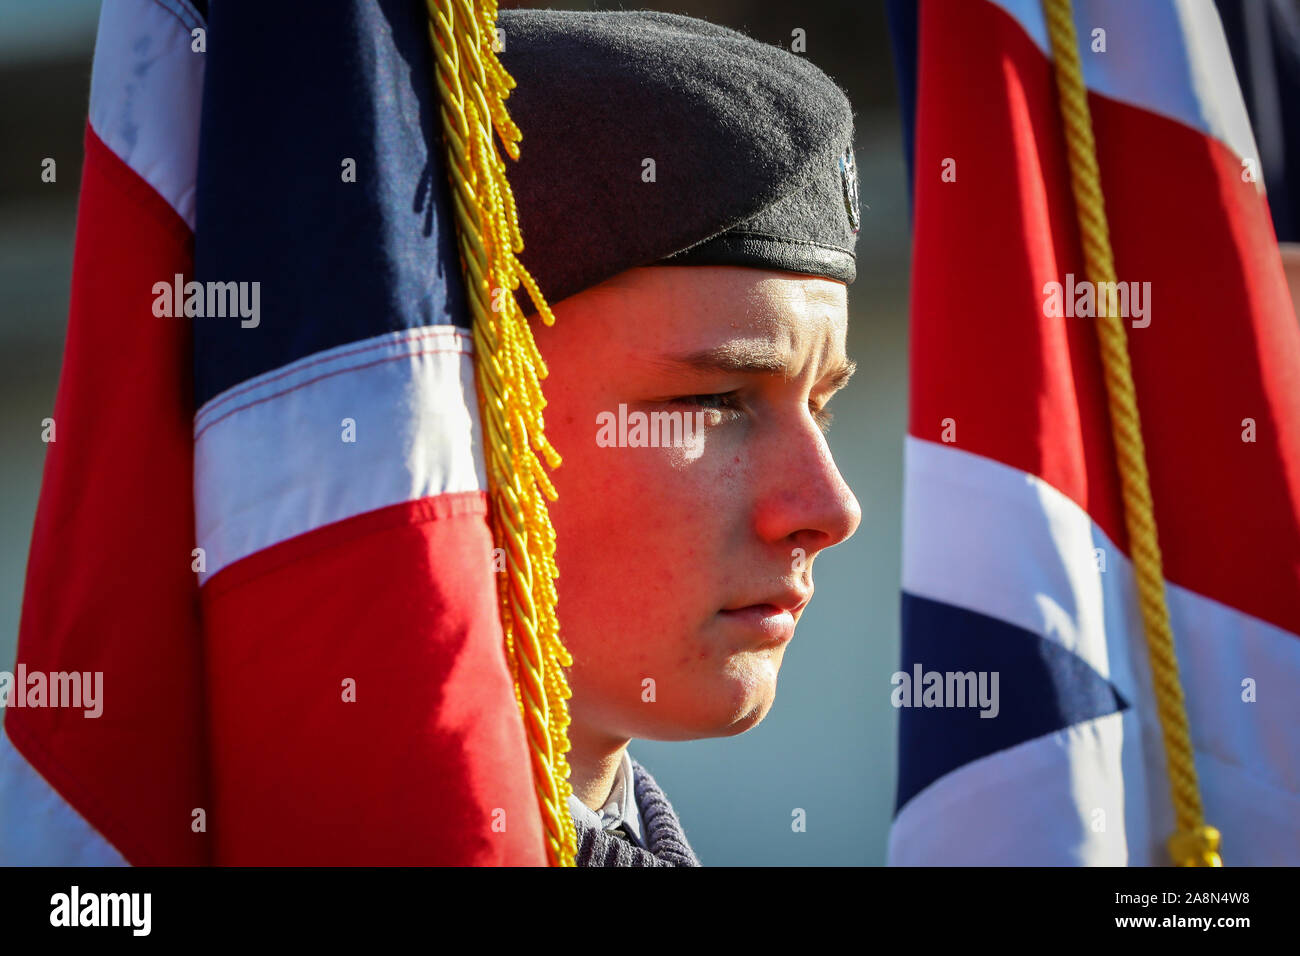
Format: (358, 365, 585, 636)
(533, 265, 862, 741)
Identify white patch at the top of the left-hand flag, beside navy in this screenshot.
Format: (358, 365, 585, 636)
(90, 0, 205, 230)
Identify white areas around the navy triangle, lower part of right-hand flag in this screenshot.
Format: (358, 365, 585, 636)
(891, 436, 1300, 865)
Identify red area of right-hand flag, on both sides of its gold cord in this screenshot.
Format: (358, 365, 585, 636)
(910, 3, 1300, 632)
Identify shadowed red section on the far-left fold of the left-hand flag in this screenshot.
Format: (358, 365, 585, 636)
(5, 126, 208, 865)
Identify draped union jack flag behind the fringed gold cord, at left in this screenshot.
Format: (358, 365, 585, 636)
(0, 0, 546, 865)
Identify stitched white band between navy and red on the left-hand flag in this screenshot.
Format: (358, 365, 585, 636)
(194, 325, 486, 583)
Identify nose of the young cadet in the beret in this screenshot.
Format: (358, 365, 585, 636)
(755, 416, 862, 558)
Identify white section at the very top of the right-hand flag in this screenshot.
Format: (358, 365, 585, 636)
(988, 0, 1264, 185)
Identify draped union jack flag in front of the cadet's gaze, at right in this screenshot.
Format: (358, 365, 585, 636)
(889, 0, 1300, 865)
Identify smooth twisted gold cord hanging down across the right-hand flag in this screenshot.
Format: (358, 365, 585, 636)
(1043, 0, 1223, 866)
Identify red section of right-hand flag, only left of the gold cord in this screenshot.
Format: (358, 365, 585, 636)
(910, 3, 1126, 544)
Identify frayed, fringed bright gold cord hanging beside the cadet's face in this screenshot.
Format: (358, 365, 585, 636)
(425, 0, 577, 866)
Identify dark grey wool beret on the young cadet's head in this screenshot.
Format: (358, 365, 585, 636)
(497, 9, 858, 311)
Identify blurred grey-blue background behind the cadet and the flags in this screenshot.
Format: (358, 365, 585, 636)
(0, 0, 910, 866)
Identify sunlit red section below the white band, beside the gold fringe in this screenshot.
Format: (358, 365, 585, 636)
(203, 492, 546, 865)
